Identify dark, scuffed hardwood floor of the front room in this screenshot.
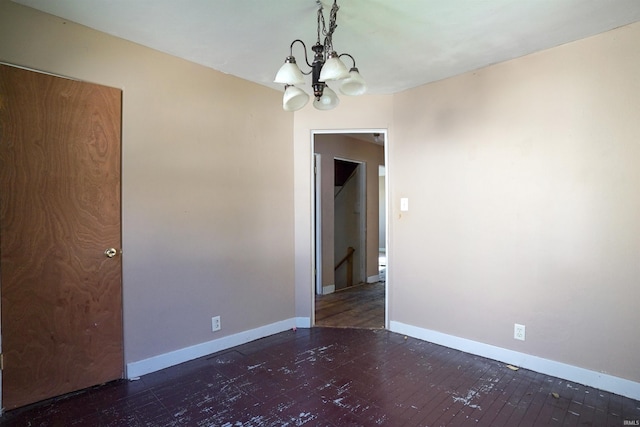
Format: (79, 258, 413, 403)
(0, 328, 640, 427)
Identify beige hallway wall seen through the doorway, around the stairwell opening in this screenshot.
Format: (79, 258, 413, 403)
(314, 134, 384, 286)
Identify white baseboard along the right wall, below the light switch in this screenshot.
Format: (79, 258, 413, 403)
(389, 321, 640, 400)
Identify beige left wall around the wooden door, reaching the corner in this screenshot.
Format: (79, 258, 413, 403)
(0, 0, 294, 363)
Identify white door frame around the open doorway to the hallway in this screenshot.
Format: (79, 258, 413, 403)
(309, 128, 392, 329)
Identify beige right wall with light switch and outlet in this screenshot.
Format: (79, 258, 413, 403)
(389, 24, 640, 381)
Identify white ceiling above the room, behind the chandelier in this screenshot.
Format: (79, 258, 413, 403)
(14, 0, 640, 93)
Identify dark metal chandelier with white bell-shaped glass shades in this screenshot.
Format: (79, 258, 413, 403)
(274, 0, 366, 111)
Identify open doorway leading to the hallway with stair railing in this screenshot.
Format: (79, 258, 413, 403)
(312, 130, 388, 328)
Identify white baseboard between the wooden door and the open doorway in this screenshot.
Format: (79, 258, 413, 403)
(126, 317, 302, 379)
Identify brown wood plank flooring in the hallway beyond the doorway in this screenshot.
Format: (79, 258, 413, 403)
(315, 282, 385, 329)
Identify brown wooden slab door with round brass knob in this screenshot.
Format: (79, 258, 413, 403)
(0, 64, 124, 409)
